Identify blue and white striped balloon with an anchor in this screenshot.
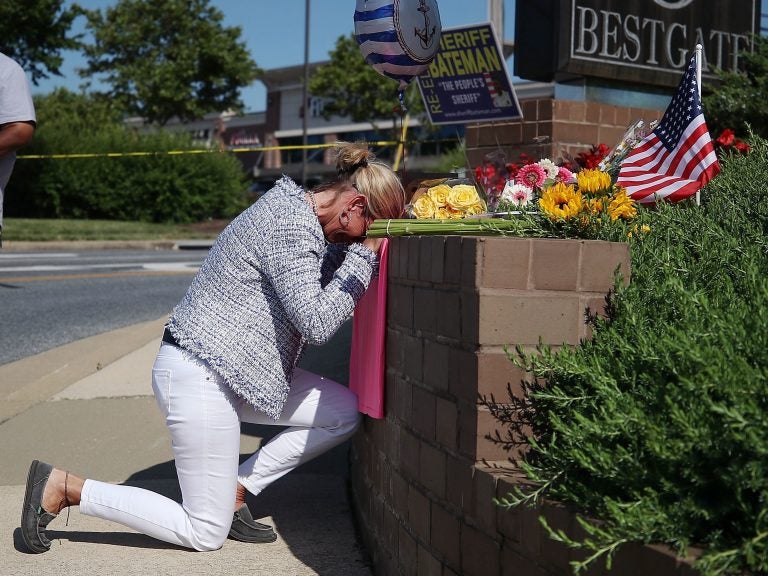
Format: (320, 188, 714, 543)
(355, 0, 442, 93)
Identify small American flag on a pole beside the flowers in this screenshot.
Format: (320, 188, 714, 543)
(616, 56, 720, 203)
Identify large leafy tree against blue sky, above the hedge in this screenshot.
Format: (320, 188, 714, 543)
(81, 0, 261, 125)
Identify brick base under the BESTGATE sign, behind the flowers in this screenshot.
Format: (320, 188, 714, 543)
(466, 98, 662, 166)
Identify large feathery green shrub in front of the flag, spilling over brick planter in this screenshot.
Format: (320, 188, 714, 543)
(490, 137, 768, 575)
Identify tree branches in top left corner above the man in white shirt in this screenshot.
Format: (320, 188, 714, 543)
(0, 0, 82, 84)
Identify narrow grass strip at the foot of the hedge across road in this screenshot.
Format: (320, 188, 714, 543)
(3, 218, 228, 242)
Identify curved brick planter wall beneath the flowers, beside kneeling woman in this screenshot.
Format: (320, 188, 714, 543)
(351, 236, 700, 576)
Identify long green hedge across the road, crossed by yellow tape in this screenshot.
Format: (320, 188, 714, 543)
(6, 90, 245, 222)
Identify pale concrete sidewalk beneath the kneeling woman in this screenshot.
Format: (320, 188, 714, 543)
(0, 319, 371, 576)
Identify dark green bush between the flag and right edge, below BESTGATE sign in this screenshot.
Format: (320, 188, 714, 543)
(703, 36, 768, 138)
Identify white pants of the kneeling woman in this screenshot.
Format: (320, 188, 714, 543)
(80, 343, 360, 550)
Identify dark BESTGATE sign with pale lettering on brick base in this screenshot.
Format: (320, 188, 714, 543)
(515, 0, 760, 86)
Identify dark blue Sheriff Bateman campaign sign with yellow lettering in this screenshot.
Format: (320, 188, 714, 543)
(416, 24, 523, 124)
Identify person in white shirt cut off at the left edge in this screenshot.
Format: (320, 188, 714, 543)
(0, 52, 37, 247)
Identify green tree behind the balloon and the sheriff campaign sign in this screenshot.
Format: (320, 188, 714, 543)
(309, 34, 424, 126)
